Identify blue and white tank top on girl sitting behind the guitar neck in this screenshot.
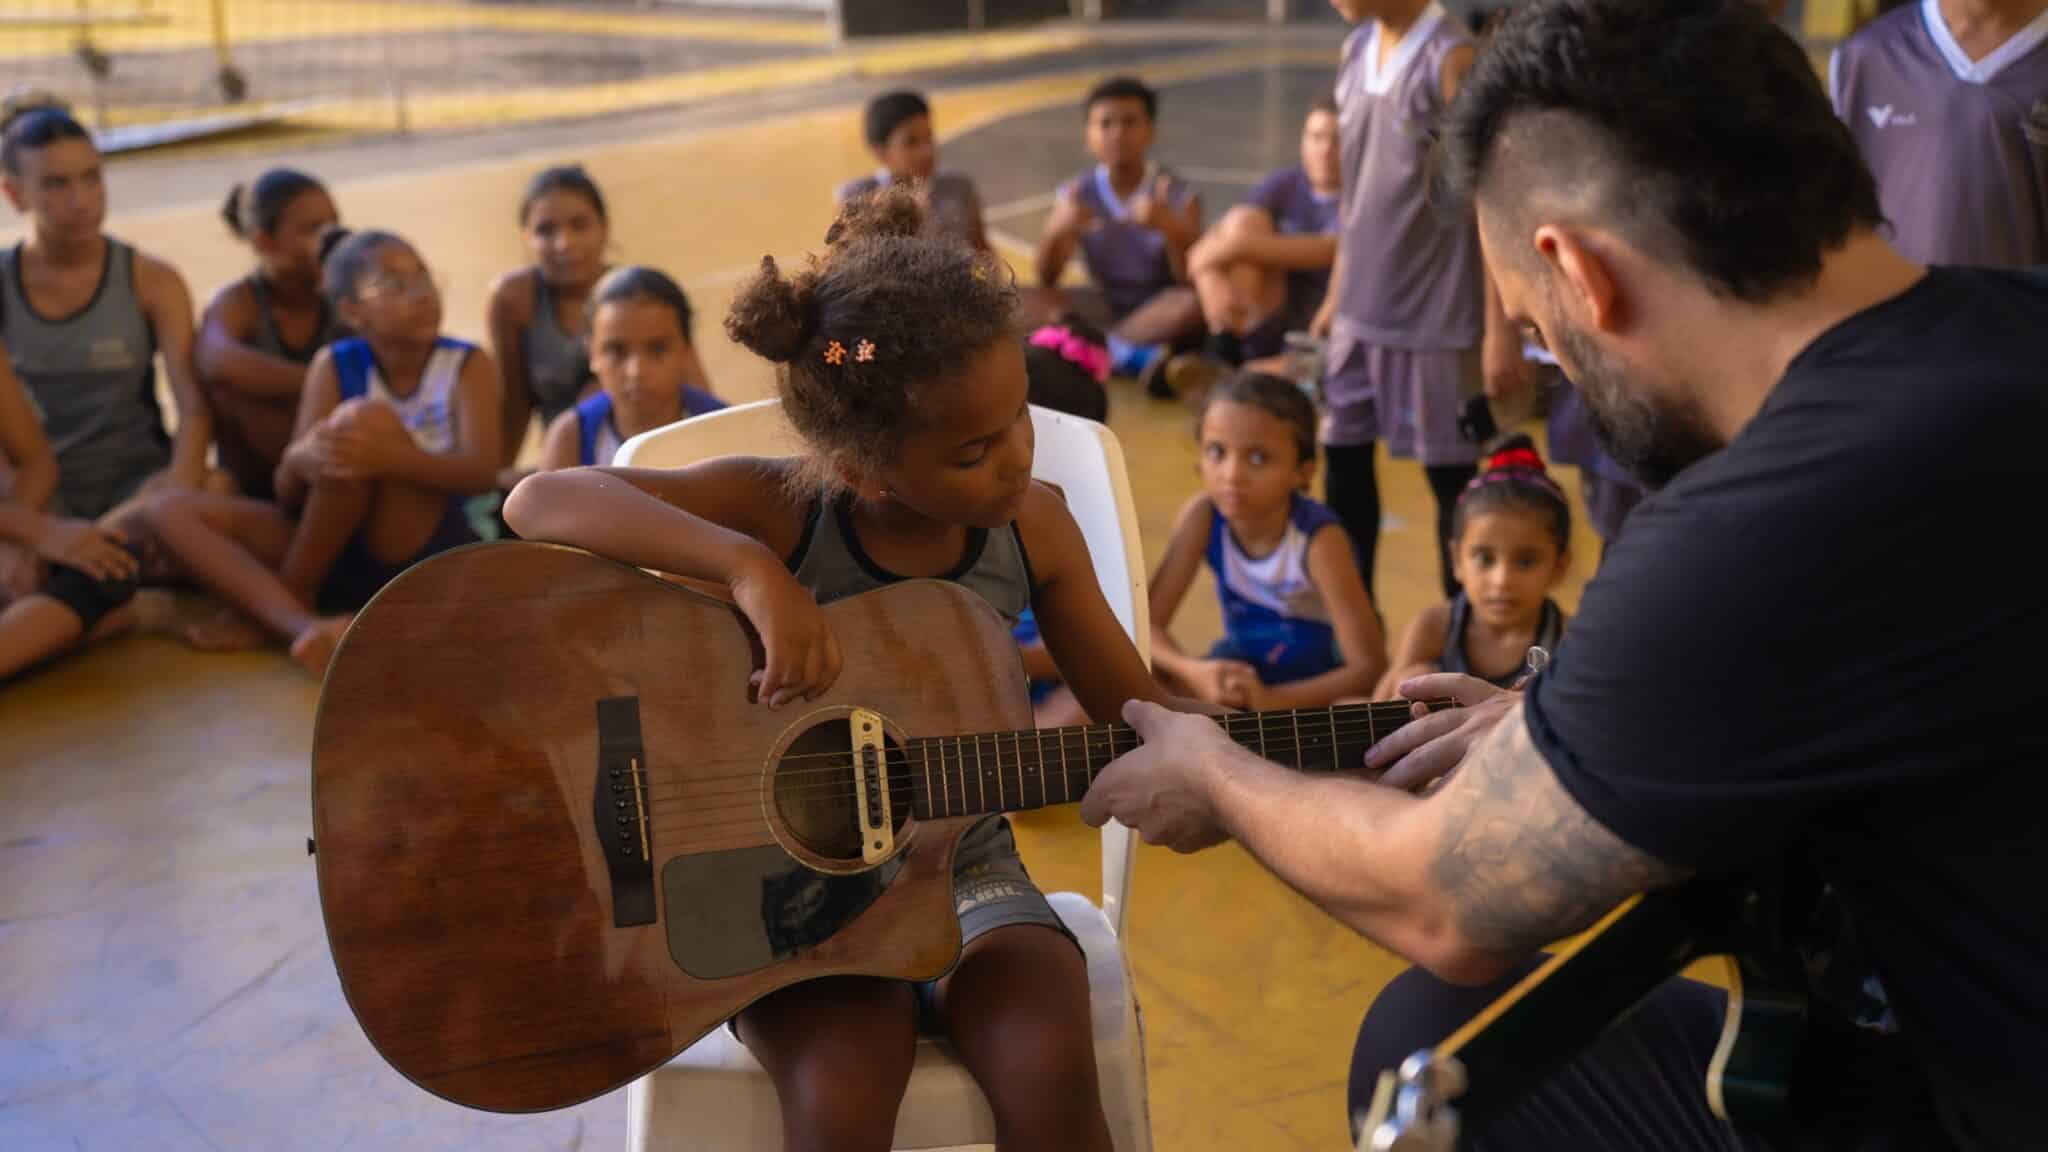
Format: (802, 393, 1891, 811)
(1206, 492, 1341, 685)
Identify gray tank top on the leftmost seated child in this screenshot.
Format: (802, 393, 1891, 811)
(0, 238, 170, 519)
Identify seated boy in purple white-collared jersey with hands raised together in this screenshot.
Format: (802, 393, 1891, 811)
(1036, 76, 1202, 392)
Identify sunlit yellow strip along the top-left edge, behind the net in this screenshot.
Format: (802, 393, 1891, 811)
(0, 0, 831, 59)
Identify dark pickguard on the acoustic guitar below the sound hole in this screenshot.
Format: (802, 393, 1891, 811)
(662, 845, 903, 980)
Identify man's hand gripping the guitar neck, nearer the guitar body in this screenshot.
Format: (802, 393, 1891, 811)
(1081, 701, 1239, 853)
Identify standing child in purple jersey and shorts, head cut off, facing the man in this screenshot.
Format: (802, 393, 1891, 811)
(1315, 0, 1528, 596)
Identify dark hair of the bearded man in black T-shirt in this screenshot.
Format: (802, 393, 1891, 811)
(1444, 0, 1884, 301)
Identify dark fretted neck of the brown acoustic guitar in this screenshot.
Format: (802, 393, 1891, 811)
(905, 701, 1434, 820)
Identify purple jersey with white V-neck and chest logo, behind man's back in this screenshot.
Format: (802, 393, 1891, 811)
(1827, 0, 2048, 266)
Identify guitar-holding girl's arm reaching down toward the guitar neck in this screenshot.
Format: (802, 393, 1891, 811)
(1011, 482, 1174, 722)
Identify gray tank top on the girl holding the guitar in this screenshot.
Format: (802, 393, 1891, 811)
(788, 487, 1032, 627)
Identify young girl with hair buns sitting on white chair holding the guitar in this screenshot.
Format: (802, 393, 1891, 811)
(506, 189, 1163, 1152)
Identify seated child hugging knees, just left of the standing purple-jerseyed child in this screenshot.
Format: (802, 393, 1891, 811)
(1188, 96, 1343, 375)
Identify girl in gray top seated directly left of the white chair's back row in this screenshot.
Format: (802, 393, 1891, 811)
(487, 166, 610, 473)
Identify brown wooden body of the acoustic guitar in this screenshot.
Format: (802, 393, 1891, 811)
(313, 543, 1030, 1111)
